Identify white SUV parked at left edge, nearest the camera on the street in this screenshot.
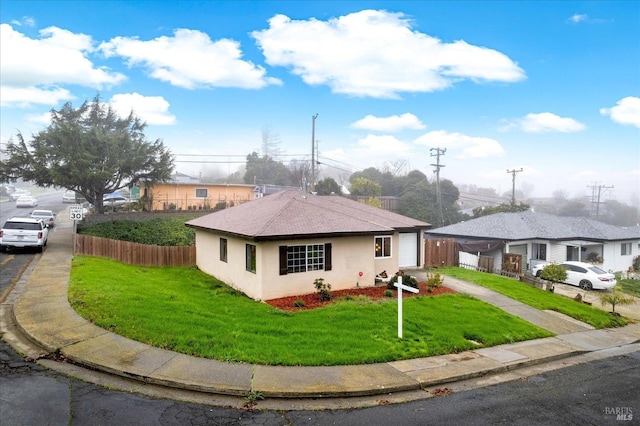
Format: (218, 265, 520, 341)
(0, 217, 49, 252)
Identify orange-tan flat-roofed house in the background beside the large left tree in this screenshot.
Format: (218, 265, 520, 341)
(140, 173, 258, 210)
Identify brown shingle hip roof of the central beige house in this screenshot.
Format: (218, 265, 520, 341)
(186, 190, 431, 240)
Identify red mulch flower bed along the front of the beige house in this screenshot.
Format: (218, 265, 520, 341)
(265, 283, 457, 312)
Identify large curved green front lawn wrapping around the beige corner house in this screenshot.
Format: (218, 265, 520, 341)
(69, 257, 552, 365)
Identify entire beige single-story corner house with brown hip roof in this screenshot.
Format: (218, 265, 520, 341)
(186, 190, 430, 300)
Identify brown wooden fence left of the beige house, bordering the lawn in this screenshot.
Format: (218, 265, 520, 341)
(76, 234, 196, 266)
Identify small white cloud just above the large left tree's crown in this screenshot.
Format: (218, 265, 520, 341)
(109, 93, 176, 126)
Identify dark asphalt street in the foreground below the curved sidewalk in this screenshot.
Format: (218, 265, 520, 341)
(0, 341, 640, 426)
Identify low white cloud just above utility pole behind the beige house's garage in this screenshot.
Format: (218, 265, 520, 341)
(415, 130, 504, 159)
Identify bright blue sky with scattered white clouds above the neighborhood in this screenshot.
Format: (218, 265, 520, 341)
(0, 0, 640, 204)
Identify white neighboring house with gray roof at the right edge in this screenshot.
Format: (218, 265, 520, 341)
(425, 210, 640, 272)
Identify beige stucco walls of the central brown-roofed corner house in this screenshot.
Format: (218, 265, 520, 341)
(196, 230, 399, 300)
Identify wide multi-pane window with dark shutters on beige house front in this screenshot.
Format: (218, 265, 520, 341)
(280, 243, 331, 275)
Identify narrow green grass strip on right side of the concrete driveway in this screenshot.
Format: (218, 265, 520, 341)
(438, 267, 627, 328)
